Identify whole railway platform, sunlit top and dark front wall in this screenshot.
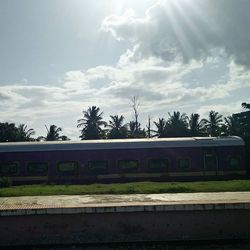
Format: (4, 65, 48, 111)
(0, 192, 250, 246)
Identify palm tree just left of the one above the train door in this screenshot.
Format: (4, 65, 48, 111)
(188, 113, 205, 136)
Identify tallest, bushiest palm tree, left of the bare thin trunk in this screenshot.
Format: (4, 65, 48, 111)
(77, 106, 106, 140)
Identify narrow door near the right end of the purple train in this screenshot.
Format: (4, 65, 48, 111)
(204, 149, 218, 176)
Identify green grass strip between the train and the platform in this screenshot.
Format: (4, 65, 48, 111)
(0, 180, 250, 197)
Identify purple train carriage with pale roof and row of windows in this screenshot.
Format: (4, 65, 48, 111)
(0, 136, 246, 185)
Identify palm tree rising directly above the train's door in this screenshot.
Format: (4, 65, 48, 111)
(204, 110, 223, 136)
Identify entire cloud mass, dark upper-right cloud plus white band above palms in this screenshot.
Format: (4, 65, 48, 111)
(0, 0, 250, 138)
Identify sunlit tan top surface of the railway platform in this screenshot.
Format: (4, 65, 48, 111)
(0, 192, 250, 210)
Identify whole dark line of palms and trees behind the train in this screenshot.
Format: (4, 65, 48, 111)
(0, 101, 250, 142)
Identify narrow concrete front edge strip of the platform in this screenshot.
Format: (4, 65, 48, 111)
(0, 202, 250, 217)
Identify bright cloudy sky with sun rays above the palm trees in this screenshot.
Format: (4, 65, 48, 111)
(0, 0, 250, 139)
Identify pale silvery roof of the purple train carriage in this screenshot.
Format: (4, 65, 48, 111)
(0, 136, 245, 152)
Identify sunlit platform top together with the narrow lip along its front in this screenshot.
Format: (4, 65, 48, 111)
(0, 192, 250, 216)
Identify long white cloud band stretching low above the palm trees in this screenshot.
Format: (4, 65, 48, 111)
(0, 53, 250, 133)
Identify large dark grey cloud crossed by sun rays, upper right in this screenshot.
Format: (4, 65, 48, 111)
(102, 0, 250, 67)
